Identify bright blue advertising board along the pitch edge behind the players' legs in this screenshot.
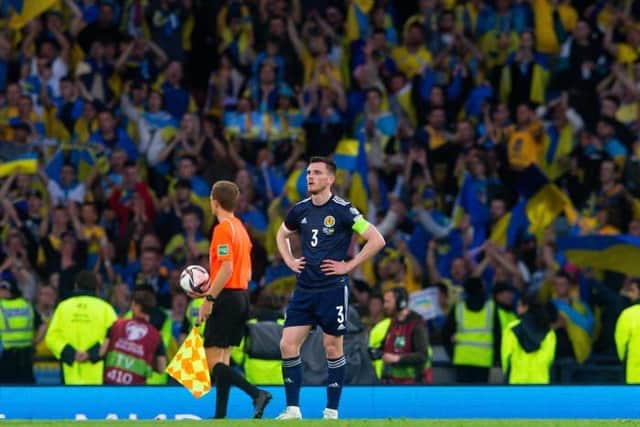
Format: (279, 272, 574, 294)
(0, 385, 640, 420)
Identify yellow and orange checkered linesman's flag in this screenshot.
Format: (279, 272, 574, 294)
(167, 328, 211, 399)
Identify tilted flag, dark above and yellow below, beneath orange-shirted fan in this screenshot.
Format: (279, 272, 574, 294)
(516, 164, 571, 237)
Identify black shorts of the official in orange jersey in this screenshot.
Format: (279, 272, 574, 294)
(204, 289, 249, 348)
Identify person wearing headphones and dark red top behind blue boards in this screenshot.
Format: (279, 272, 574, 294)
(369, 287, 430, 384)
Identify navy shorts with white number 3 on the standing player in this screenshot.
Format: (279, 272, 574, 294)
(284, 286, 349, 337)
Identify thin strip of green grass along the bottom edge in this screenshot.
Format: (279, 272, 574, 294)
(0, 418, 640, 427)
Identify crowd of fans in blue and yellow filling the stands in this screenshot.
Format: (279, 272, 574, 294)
(0, 0, 640, 383)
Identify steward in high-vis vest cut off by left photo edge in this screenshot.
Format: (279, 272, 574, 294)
(0, 280, 40, 384)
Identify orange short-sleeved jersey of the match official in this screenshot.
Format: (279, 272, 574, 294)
(209, 216, 252, 289)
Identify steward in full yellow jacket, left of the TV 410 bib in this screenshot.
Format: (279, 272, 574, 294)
(45, 270, 118, 385)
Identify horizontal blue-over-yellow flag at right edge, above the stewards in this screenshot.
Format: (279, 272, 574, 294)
(557, 234, 640, 276)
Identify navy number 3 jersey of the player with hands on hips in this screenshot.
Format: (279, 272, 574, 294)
(284, 196, 362, 289)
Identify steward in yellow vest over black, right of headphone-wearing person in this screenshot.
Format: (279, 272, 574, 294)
(442, 277, 501, 383)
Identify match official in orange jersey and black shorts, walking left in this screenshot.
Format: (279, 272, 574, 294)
(198, 181, 271, 418)
